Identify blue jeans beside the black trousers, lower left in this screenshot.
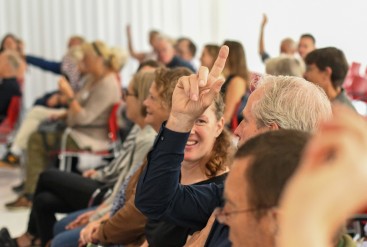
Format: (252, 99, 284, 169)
(51, 207, 97, 247)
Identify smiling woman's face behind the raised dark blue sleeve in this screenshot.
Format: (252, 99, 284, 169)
(184, 104, 224, 163)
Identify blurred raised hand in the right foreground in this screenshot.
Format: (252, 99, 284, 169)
(278, 107, 367, 247)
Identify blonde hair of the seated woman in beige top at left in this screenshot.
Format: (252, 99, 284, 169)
(83, 40, 128, 72)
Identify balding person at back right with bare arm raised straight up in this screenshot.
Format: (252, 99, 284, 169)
(259, 14, 297, 62)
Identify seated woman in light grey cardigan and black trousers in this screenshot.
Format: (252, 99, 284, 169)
(1, 69, 156, 246)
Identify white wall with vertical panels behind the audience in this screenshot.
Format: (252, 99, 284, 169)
(0, 0, 367, 110)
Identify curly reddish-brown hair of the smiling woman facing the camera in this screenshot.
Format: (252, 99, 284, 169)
(205, 94, 234, 178)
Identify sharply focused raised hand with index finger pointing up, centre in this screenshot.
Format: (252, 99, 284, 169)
(166, 46, 229, 132)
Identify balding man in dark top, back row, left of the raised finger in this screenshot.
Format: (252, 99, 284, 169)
(156, 37, 195, 71)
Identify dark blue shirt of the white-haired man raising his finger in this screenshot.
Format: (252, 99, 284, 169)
(135, 126, 230, 246)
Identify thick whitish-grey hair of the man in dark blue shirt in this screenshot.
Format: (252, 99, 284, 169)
(251, 75, 332, 132)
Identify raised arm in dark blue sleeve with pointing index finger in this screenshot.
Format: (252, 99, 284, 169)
(135, 46, 229, 230)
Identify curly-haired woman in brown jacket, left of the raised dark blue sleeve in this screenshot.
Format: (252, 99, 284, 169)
(76, 68, 191, 245)
